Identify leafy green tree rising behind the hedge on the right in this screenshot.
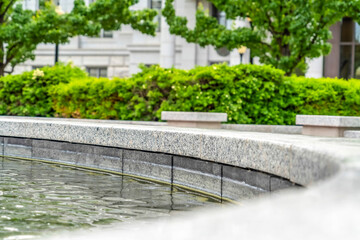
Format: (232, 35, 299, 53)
(162, 0, 360, 75)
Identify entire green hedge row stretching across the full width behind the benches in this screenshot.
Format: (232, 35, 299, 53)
(0, 65, 360, 124)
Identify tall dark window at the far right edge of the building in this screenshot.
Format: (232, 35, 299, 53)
(339, 18, 360, 79)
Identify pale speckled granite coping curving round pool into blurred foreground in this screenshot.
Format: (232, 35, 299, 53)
(0, 117, 360, 240)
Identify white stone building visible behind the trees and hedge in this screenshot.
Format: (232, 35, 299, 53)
(15, 0, 360, 77)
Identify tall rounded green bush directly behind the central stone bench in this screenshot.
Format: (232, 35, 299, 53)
(158, 65, 295, 124)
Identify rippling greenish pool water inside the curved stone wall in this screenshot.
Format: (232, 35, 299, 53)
(0, 157, 219, 240)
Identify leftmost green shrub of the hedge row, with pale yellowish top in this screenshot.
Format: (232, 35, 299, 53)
(0, 64, 86, 117)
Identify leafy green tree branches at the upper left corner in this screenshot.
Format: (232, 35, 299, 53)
(0, 0, 156, 76)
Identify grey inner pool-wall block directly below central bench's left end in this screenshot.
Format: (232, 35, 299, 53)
(123, 150, 171, 183)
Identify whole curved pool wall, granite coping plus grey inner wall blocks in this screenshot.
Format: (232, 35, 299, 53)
(0, 117, 360, 240)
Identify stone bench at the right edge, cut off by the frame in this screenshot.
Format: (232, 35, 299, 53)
(296, 115, 360, 137)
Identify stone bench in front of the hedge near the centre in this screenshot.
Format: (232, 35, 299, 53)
(161, 111, 227, 129)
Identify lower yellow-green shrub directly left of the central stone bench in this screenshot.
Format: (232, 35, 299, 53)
(51, 66, 185, 120)
